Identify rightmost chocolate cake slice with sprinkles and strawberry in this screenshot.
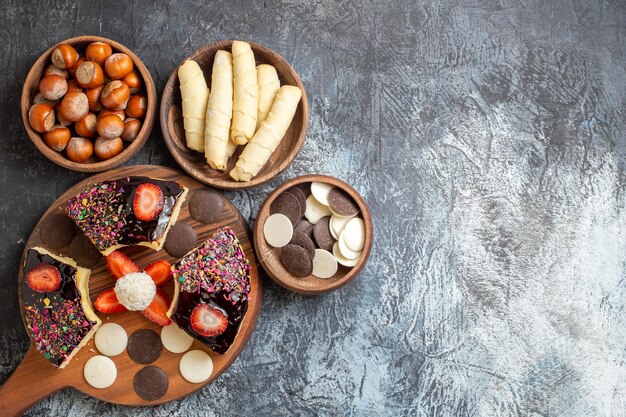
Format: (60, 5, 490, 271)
(168, 227, 250, 353)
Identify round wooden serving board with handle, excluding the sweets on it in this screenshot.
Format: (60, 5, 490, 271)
(0, 165, 262, 416)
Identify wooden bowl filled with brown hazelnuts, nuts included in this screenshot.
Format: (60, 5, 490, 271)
(21, 36, 157, 172)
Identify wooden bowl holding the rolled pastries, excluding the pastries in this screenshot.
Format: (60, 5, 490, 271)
(160, 40, 309, 189)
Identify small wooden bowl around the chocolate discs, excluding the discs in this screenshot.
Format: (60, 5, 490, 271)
(254, 175, 374, 294)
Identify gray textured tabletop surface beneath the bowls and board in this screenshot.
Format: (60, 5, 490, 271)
(0, 0, 626, 417)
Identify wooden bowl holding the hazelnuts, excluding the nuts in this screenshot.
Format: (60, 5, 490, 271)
(21, 36, 157, 172)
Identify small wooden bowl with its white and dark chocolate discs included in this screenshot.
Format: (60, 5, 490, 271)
(254, 175, 374, 294)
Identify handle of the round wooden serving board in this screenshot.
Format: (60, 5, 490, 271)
(0, 344, 69, 417)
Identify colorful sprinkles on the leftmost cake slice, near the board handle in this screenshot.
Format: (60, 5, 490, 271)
(24, 299, 94, 367)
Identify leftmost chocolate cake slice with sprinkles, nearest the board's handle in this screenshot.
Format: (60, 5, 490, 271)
(22, 247, 102, 368)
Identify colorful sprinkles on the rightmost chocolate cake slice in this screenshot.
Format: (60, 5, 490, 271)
(174, 226, 250, 304)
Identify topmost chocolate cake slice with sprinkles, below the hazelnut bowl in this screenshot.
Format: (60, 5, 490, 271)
(66, 177, 187, 256)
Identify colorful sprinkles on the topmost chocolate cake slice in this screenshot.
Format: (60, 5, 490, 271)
(66, 181, 127, 250)
